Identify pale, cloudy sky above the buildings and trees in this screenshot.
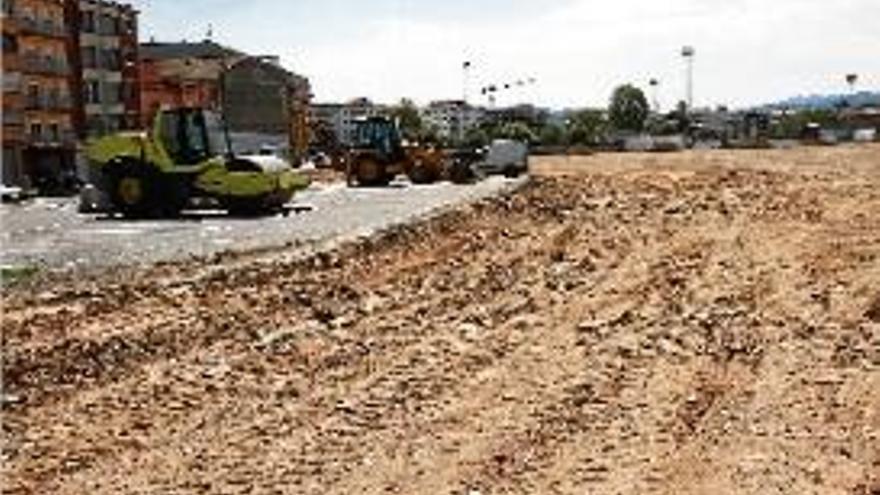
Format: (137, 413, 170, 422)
(133, 0, 880, 108)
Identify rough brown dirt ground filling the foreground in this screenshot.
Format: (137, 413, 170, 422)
(2, 146, 880, 495)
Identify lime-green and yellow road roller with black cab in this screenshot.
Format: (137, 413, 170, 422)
(87, 108, 308, 217)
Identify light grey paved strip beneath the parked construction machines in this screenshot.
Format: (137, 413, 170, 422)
(0, 177, 519, 270)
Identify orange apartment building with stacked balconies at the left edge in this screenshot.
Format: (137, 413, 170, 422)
(3, 0, 75, 190)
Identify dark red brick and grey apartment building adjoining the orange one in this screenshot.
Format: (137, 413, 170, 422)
(68, 0, 141, 138)
